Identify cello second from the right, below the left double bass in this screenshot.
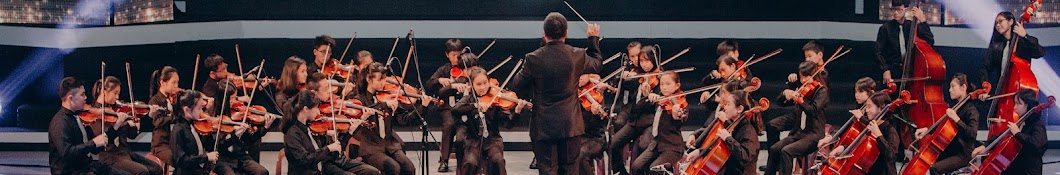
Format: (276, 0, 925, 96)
(901, 83, 990, 175)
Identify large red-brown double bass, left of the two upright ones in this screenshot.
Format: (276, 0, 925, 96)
(898, 2, 949, 146)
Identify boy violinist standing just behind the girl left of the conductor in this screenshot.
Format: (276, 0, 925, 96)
(425, 39, 475, 173)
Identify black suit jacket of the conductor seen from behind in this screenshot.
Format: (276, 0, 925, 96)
(511, 37, 601, 140)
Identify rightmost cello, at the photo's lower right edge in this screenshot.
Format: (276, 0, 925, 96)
(972, 97, 1056, 175)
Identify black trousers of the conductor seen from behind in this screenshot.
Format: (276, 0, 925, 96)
(532, 137, 581, 175)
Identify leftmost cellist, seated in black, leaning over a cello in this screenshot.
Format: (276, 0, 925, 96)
(685, 90, 767, 175)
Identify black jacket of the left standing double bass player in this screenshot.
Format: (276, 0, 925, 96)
(876, 20, 935, 75)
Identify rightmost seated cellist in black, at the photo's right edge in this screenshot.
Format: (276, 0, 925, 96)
(970, 89, 1052, 174)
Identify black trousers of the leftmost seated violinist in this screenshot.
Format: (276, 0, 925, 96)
(100, 152, 162, 175)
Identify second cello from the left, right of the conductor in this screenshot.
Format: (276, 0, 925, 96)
(822, 91, 915, 175)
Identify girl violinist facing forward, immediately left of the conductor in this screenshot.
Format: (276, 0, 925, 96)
(453, 67, 527, 175)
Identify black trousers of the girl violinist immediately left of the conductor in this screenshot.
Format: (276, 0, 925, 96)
(460, 136, 508, 175)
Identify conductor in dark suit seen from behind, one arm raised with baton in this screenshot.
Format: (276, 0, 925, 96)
(511, 12, 601, 175)
